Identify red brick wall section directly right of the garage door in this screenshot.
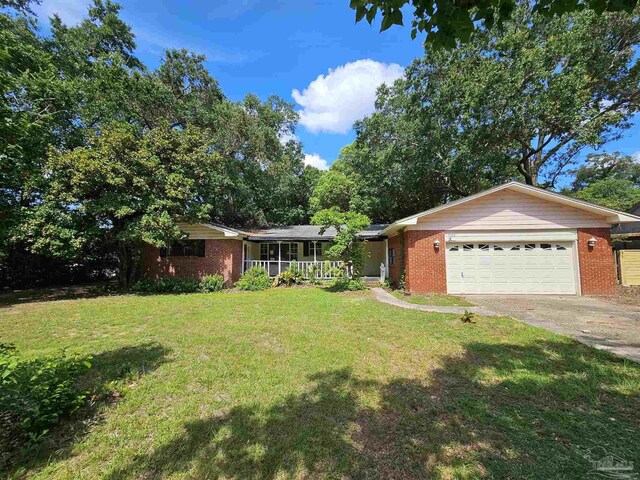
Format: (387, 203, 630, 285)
(578, 228, 617, 295)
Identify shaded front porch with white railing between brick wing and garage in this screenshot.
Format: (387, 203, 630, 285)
(242, 240, 388, 282)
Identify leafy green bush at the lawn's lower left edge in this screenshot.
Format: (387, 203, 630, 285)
(0, 344, 91, 451)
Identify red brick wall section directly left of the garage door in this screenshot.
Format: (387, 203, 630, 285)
(404, 230, 447, 293)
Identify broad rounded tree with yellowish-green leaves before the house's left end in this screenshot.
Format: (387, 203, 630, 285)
(22, 125, 224, 286)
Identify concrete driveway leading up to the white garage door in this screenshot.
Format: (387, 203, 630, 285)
(464, 295, 640, 363)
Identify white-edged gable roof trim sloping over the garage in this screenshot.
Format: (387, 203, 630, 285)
(381, 181, 640, 235)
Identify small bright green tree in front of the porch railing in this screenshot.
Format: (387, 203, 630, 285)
(311, 207, 371, 278)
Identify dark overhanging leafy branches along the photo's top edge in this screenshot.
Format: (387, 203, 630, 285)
(350, 0, 637, 48)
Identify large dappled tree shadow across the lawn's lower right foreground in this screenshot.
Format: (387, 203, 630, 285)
(108, 342, 640, 480)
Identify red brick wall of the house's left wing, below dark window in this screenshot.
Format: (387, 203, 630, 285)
(144, 240, 242, 286)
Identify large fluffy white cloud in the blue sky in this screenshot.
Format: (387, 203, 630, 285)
(291, 59, 403, 133)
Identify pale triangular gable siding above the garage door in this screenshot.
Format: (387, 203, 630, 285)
(408, 190, 609, 230)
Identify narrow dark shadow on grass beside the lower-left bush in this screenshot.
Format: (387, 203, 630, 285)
(0, 343, 170, 476)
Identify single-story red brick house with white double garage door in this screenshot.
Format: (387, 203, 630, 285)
(145, 182, 640, 295)
